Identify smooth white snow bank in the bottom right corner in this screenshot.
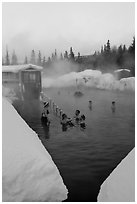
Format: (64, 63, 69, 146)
(98, 149, 135, 202)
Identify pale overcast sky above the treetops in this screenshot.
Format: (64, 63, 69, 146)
(2, 2, 135, 60)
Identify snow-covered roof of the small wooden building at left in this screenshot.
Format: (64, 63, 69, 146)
(2, 64, 43, 73)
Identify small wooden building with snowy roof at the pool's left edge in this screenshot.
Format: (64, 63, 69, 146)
(2, 64, 43, 99)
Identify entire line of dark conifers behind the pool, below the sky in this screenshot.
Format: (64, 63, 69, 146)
(2, 37, 135, 76)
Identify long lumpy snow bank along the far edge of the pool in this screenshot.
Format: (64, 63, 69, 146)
(42, 69, 135, 91)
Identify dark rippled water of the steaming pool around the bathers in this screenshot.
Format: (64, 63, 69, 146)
(14, 88, 135, 202)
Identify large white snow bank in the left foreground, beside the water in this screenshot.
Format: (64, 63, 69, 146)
(2, 99, 68, 202)
